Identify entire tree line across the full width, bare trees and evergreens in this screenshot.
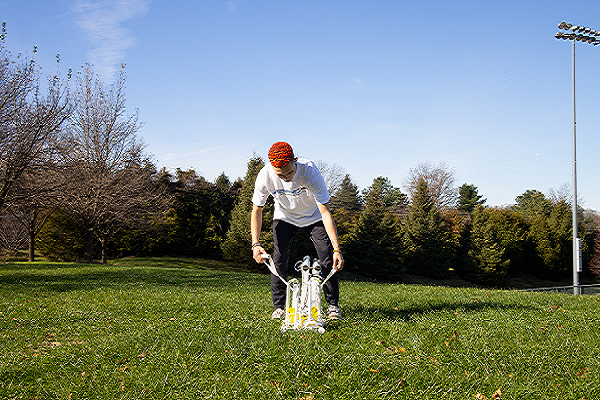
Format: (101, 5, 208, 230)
(0, 30, 600, 286)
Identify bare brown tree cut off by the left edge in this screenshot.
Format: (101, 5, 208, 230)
(0, 27, 70, 212)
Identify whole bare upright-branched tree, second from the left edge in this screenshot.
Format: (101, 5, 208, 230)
(63, 65, 158, 262)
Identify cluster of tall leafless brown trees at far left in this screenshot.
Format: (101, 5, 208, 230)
(0, 28, 167, 261)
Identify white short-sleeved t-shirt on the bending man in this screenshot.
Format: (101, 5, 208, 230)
(252, 158, 330, 227)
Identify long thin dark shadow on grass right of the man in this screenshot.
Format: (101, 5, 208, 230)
(345, 301, 535, 322)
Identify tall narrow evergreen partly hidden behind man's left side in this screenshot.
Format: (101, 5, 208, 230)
(221, 155, 273, 267)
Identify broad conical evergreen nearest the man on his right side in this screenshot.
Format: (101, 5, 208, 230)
(343, 178, 404, 279)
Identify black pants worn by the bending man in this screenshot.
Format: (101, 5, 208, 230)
(271, 220, 340, 309)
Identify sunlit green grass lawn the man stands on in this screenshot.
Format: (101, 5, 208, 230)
(0, 258, 600, 400)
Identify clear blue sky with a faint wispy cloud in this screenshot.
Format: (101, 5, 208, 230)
(0, 0, 600, 210)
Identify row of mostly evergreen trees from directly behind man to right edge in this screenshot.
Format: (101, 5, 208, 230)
(222, 157, 600, 286)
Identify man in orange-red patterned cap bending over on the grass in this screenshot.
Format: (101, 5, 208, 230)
(250, 142, 344, 319)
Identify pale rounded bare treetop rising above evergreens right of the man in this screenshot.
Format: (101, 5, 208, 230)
(404, 162, 458, 210)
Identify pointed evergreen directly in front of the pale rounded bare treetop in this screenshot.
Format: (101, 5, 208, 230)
(403, 178, 454, 278)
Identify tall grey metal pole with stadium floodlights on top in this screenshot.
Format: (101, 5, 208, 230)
(554, 21, 600, 295)
